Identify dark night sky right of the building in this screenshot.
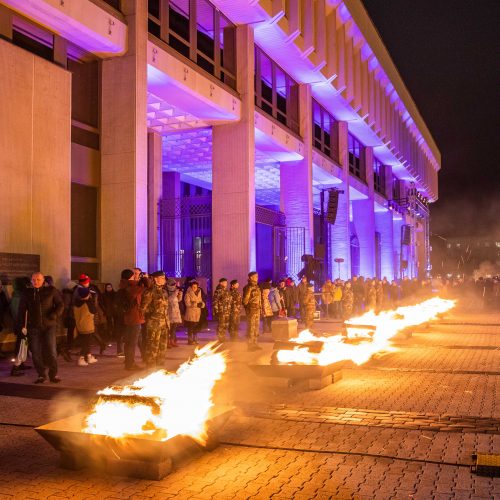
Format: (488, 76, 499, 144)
(362, 0, 500, 236)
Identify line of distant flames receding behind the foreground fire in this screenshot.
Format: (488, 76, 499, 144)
(277, 297, 455, 366)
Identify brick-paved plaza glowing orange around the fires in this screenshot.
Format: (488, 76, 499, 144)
(0, 313, 500, 499)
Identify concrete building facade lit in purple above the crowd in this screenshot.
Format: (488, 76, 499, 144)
(0, 0, 441, 288)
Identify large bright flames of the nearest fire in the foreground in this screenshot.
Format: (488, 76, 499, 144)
(82, 344, 226, 444)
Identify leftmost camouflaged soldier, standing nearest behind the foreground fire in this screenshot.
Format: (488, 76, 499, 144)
(141, 271, 169, 366)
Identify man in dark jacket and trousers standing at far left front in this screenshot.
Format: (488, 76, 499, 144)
(17, 273, 64, 384)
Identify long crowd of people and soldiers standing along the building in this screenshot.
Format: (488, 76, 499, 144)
(0, 268, 480, 383)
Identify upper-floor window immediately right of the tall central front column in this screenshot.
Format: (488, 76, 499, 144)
(255, 46, 299, 134)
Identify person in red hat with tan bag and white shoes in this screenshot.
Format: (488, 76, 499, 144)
(73, 286, 97, 366)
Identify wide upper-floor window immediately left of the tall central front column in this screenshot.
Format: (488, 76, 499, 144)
(148, 0, 236, 89)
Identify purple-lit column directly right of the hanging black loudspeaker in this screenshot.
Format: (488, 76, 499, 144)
(329, 122, 351, 280)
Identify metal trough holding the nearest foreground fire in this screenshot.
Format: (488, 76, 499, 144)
(35, 407, 233, 480)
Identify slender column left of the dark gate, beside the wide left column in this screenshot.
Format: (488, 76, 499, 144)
(148, 132, 163, 273)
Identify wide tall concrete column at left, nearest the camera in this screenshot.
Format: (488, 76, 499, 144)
(101, 0, 148, 282)
